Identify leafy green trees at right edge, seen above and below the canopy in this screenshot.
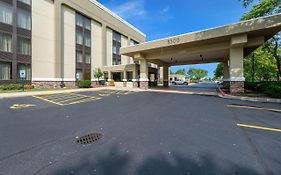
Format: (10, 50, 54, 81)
(240, 0, 281, 81)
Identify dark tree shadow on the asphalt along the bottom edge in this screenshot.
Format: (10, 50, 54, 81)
(48, 148, 259, 175)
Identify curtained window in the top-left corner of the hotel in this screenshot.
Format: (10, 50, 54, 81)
(0, 1, 13, 25)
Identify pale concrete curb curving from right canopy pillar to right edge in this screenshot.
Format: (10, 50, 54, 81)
(218, 86, 281, 104)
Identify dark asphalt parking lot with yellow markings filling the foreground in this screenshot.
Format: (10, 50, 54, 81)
(0, 90, 281, 175)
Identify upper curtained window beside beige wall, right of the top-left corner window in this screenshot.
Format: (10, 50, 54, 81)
(17, 9, 31, 30)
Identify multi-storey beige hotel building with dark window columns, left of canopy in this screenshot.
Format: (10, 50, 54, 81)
(0, 0, 160, 87)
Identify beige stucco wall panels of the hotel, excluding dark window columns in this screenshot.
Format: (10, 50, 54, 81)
(32, 0, 145, 85)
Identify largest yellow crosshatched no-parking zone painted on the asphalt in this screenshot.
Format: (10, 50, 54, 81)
(33, 93, 101, 106)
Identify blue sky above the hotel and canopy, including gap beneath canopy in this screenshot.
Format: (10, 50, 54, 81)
(98, 0, 255, 77)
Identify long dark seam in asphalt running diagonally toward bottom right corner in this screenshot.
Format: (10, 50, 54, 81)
(226, 106, 273, 175)
